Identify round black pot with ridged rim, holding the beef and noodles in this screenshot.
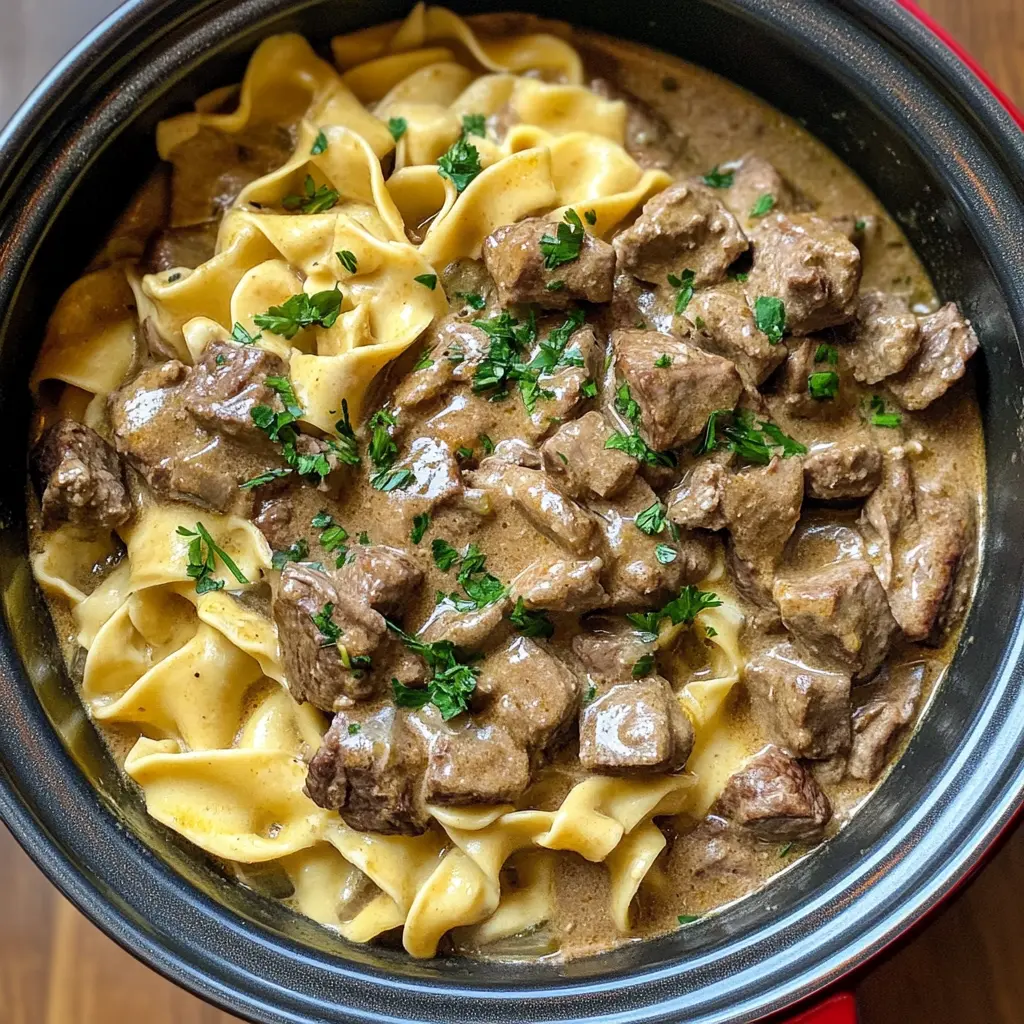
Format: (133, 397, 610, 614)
(0, 0, 1024, 1024)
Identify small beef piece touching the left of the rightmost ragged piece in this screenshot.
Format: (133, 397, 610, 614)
(843, 292, 922, 384)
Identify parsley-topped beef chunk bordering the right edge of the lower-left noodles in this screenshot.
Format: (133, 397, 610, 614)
(273, 562, 425, 711)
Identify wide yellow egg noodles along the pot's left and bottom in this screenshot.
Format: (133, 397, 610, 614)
(33, 4, 745, 956)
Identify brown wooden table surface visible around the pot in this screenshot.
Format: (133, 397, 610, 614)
(0, 0, 1024, 1024)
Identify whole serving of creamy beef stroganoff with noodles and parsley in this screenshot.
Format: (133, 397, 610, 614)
(29, 5, 984, 957)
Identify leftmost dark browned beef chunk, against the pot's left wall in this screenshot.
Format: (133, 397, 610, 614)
(32, 420, 131, 529)
